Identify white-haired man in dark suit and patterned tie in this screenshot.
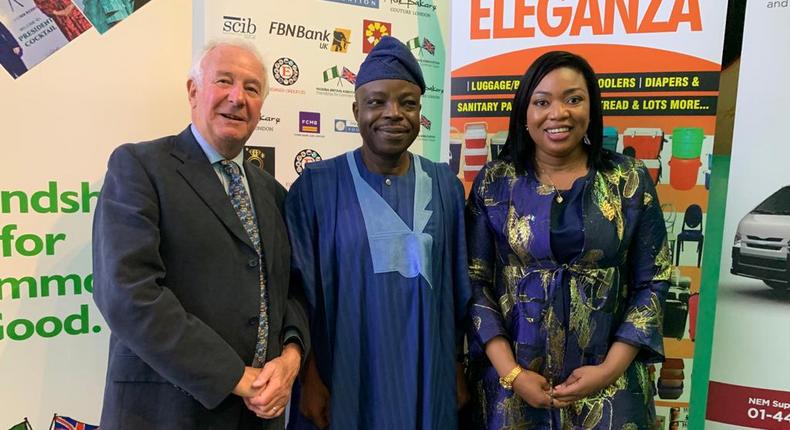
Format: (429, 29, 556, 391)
(93, 38, 308, 429)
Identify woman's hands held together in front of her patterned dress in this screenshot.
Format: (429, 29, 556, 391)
(513, 364, 619, 409)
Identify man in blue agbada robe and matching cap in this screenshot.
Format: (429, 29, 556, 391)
(286, 37, 470, 430)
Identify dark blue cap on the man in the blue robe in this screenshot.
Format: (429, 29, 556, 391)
(354, 36, 425, 94)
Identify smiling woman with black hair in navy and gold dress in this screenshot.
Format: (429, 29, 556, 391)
(466, 51, 671, 429)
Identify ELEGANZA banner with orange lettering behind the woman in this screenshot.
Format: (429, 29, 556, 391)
(449, 0, 727, 429)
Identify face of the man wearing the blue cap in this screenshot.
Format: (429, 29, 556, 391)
(353, 79, 420, 158)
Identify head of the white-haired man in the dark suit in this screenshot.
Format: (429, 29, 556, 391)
(187, 45, 266, 158)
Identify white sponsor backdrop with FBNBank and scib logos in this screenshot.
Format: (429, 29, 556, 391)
(193, 0, 450, 187)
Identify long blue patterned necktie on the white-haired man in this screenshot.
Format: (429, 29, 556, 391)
(220, 160, 269, 367)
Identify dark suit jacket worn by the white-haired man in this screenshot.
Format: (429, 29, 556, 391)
(93, 127, 308, 429)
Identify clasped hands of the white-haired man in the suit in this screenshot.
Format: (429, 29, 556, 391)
(233, 344, 301, 419)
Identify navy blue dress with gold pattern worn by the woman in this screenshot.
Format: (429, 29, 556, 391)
(466, 154, 671, 429)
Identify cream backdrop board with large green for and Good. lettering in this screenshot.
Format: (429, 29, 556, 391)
(0, 0, 192, 430)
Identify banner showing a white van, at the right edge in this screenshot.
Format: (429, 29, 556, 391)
(705, 1, 790, 429)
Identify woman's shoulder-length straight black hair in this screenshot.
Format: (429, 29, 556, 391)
(499, 51, 611, 174)
